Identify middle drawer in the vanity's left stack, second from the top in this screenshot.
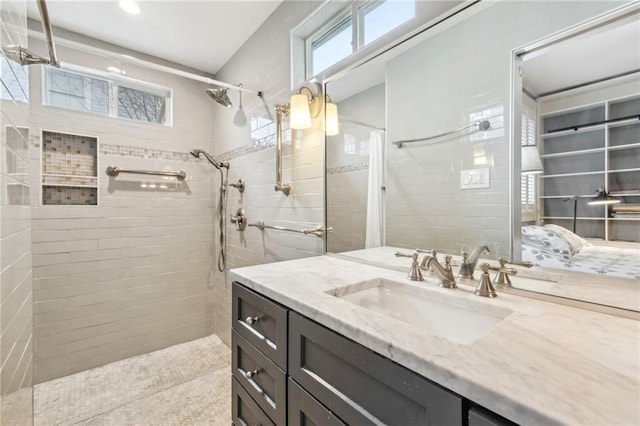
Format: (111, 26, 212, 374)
(231, 331, 287, 425)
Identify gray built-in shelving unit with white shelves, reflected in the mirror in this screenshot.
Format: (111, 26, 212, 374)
(539, 93, 640, 242)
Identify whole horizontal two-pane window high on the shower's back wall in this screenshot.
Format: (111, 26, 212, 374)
(44, 67, 171, 126)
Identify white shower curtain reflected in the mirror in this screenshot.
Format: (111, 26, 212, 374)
(365, 130, 385, 248)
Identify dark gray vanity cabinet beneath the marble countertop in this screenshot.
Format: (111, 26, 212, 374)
(231, 283, 512, 426)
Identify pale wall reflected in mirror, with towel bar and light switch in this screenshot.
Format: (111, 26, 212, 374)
(387, 1, 620, 256)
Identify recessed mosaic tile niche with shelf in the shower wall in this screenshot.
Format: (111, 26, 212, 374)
(42, 131, 98, 206)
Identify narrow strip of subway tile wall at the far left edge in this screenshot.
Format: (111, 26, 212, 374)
(0, 1, 33, 425)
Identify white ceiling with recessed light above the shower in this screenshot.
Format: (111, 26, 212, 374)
(27, 0, 282, 74)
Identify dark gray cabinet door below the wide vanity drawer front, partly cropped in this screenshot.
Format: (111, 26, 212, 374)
(287, 379, 345, 426)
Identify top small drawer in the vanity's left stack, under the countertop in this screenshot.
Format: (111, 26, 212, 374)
(232, 282, 287, 370)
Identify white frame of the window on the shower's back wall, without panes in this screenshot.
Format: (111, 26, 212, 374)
(42, 63, 173, 127)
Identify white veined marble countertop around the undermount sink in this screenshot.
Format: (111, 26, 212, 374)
(230, 256, 640, 425)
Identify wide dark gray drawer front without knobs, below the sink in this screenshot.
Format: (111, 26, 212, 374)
(289, 312, 466, 426)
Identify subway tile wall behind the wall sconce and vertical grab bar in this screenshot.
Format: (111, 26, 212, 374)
(215, 1, 324, 345)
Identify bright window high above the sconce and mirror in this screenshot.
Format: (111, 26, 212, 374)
(302, 0, 416, 78)
